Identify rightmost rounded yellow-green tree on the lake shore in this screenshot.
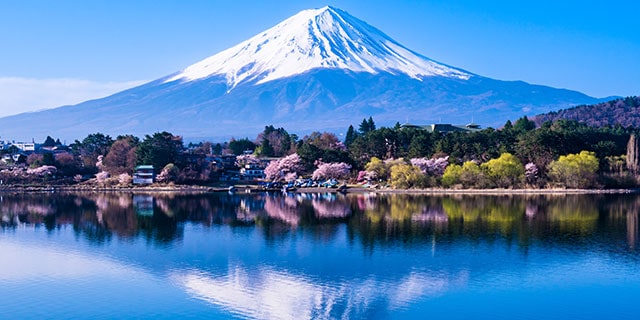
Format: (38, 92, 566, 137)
(549, 151, 599, 188)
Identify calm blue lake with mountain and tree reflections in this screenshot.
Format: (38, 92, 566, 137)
(0, 193, 640, 319)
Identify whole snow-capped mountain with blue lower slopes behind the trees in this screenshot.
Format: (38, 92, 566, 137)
(0, 7, 601, 140)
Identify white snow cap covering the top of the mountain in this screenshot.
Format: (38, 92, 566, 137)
(167, 6, 471, 88)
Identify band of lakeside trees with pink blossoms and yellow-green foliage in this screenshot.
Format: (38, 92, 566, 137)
(0, 111, 640, 189)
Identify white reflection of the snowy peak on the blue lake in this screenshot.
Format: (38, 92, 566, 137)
(170, 267, 467, 319)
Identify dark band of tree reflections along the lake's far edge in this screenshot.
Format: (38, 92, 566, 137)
(0, 193, 640, 250)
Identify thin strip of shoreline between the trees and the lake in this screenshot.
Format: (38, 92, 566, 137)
(0, 185, 640, 195)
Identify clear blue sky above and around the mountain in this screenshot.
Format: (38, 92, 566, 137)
(0, 0, 640, 116)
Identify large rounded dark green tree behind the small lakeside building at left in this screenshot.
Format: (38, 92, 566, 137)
(136, 131, 184, 170)
